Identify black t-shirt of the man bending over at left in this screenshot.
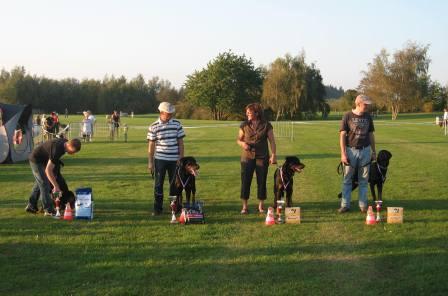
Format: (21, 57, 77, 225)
(28, 139, 67, 165)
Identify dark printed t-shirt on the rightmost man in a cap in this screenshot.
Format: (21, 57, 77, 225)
(339, 111, 375, 148)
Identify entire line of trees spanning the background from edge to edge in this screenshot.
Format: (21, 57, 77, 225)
(0, 42, 448, 120)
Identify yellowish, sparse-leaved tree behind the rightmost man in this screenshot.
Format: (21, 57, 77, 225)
(359, 42, 430, 119)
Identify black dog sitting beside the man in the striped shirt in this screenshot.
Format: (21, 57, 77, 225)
(174, 156, 199, 212)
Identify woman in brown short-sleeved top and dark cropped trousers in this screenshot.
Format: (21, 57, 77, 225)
(236, 103, 277, 214)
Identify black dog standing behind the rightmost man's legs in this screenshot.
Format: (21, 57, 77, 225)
(338, 150, 392, 201)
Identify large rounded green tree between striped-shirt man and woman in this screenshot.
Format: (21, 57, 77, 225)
(185, 51, 262, 120)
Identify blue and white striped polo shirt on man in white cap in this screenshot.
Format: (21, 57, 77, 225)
(146, 118, 185, 161)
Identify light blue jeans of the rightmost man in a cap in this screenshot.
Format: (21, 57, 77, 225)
(341, 146, 371, 208)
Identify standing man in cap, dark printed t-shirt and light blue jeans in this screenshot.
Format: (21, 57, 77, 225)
(339, 95, 376, 213)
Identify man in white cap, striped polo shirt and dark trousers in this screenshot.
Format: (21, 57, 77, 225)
(147, 102, 185, 215)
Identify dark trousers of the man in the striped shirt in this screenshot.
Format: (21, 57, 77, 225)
(154, 158, 177, 213)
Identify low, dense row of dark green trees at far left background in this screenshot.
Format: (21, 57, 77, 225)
(0, 67, 183, 113)
